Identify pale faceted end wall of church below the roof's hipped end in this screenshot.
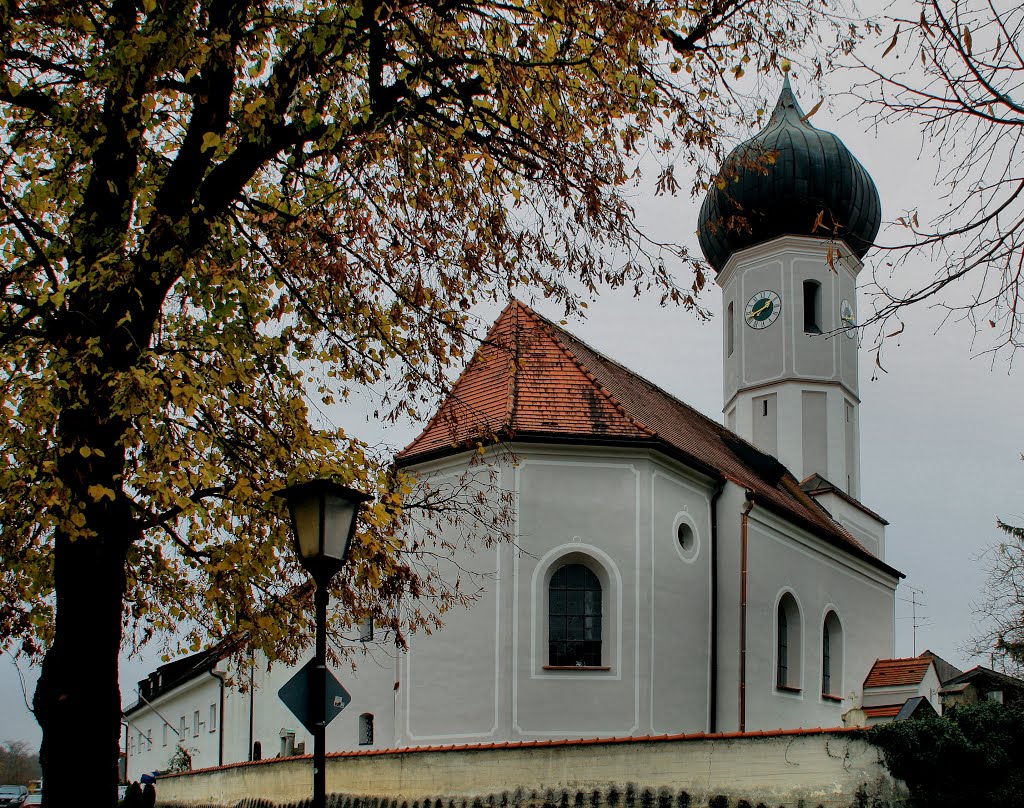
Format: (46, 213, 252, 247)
(398, 446, 711, 746)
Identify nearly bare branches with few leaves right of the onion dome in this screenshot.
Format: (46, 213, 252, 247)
(854, 0, 1024, 352)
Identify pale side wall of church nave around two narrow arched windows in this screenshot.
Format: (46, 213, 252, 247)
(718, 483, 896, 731)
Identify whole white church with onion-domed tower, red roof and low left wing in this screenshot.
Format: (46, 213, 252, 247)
(126, 81, 913, 777)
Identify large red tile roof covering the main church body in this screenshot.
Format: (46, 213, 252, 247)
(396, 300, 901, 576)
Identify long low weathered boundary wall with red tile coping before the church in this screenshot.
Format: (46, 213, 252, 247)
(157, 729, 906, 808)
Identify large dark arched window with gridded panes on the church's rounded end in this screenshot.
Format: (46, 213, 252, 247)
(548, 564, 601, 668)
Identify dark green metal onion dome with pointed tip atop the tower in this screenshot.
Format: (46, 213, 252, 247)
(697, 75, 882, 271)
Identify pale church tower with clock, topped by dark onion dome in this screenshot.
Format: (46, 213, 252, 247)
(698, 74, 882, 498)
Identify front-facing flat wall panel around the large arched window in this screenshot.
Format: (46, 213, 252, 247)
(512, 450, 649, 738)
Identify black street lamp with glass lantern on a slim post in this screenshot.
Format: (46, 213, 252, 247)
(278, 479, 371, 808)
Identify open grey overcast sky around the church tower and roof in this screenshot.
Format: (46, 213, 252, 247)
(0, 23, 1024, 745)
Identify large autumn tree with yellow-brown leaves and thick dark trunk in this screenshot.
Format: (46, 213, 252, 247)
(0, 0, 849, 807)
